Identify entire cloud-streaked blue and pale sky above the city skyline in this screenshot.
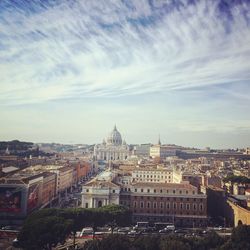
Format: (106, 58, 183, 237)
(0, 0, 250, 148)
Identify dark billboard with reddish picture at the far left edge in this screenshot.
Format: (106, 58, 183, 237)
(0, 186, 22, 213)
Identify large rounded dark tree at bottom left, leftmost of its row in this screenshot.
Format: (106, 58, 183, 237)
(18, 216, 73, 250)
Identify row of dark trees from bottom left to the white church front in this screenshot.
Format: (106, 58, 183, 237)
(17, 205, 131, 250)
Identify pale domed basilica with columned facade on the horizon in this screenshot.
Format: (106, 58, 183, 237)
(94, 126, 129, 161)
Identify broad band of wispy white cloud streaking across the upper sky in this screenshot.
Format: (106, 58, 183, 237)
(0, 0, 250, 105)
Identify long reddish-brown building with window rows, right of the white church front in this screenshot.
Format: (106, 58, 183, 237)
(129, 183, 207, 226)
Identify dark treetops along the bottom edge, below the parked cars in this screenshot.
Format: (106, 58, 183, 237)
(82, 225, 250, 250)
